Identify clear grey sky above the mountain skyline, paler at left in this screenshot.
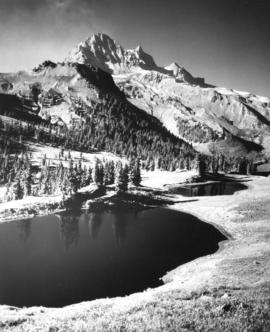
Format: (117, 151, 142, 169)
(0, 0, 270, 97)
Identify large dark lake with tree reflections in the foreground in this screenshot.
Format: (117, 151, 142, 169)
(0, 208, 225, 307)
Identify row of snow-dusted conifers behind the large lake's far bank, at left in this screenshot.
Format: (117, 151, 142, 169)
(3, 153, 141, 201)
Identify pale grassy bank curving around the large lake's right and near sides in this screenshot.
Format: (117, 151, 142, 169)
(0, 177, 270, 332)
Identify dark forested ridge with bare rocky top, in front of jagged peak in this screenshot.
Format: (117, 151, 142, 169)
(0, 61, 194, 169)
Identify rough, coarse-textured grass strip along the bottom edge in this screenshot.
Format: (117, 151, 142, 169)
(0, 284, 270, 332)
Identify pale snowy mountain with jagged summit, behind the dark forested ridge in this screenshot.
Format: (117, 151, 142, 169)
(67, 34, 270, 158)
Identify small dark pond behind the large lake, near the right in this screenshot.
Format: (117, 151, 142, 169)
(169, 182, 247, 197)
